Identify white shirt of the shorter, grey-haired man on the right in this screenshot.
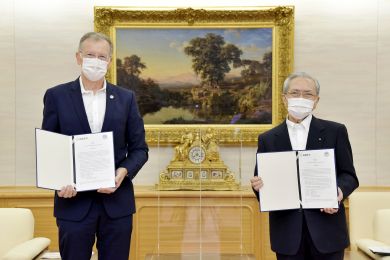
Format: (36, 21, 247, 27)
(286, 114, 313, 150)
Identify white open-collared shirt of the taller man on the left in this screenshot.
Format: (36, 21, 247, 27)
(79, 77, 107, 133)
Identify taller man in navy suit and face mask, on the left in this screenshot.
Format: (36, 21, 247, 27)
(42, 32, 148, 260)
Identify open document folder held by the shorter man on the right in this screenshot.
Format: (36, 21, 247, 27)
(257, 149, 338, 211)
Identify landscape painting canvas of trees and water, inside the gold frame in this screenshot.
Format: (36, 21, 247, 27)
(116, 28, 273, 124)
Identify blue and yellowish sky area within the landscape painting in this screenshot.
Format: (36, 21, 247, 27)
(116, 28, 272, 83)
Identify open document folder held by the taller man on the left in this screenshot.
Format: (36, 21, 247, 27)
(35, 129, 115, 191)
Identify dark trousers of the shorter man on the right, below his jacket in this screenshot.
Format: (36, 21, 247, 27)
(276, 213, 344, 260)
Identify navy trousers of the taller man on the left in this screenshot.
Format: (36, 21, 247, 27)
(57, 197, 133, 260)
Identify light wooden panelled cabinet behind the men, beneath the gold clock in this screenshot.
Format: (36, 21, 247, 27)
(0, 186, 275, 260)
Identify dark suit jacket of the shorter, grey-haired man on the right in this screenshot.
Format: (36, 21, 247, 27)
(255, 116, 359, 255)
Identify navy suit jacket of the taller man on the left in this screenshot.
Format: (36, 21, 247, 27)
(42, 79, 148, 221)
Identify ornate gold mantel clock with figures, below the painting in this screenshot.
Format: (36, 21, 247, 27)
(156, 128, 239, 190)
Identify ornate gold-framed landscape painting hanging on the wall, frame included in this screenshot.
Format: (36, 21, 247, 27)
(94, 6, 294, 145)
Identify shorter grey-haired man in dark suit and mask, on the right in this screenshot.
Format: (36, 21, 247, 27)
(251, 73, 359, 260)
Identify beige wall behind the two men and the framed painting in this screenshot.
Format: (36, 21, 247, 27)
(0, 0, 390, 185)
